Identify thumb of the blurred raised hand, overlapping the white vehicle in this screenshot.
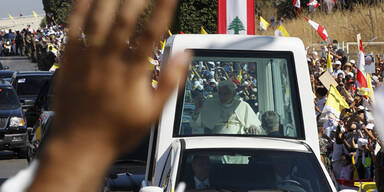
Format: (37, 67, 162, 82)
(153, 52, 192, 117)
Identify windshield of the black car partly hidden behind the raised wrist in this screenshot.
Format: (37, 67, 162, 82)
(16, 76, 51, 96)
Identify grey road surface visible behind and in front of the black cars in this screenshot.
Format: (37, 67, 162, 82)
(0, 57, 37, 183)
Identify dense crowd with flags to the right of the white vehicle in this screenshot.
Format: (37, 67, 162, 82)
(308, 41, 384, 186)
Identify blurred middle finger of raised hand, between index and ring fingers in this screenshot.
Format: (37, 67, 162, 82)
(108, 0, 150, 54)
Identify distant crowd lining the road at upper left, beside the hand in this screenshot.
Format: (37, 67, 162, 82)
(0, 25, 65, 71)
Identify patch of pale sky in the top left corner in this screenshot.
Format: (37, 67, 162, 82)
(0, 0, 45, 18)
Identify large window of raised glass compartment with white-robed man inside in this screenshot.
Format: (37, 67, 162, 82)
(173, 50, 304, 139)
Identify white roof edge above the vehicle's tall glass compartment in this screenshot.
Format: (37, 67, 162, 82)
(168, 34, 305, 52)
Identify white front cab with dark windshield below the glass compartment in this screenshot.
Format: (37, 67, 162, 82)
(144, 137, 336, 192)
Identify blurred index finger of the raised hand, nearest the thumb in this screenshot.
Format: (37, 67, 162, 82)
(135, 0, 177, 61)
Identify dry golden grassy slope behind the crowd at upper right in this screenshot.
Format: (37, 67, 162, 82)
(261, 3, 384, 53)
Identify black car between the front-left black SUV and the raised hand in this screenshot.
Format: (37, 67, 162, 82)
(11, 71, 53, 127)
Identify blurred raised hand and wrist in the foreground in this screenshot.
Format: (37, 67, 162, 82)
(28, 0, 190, 192)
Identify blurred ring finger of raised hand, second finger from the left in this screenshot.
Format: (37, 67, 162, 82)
(85, 0, 120, 48)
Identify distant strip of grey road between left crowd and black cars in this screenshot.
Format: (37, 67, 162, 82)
(0, 56, 38, 71)
